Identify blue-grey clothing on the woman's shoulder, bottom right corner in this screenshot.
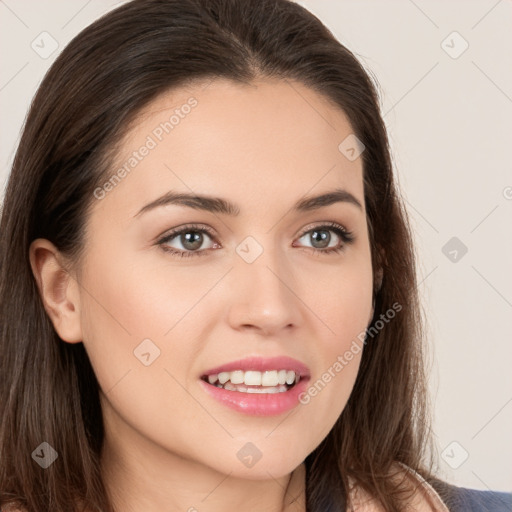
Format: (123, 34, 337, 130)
(430, 479, 512, 512)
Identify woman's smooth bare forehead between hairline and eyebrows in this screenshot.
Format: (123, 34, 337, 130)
(94, 80, 364, 220)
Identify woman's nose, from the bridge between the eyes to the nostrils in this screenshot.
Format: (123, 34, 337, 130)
(229, 244, 304, 336)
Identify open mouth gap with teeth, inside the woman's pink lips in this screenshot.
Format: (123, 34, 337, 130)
(201, 369, 306, 394)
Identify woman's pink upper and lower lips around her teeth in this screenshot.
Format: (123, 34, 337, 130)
(199, 356, 310, 416)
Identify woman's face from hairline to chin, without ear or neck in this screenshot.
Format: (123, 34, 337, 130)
(77, 80, 372, 479)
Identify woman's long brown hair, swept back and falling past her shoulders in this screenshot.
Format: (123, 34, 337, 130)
(0, 0, 433, 512)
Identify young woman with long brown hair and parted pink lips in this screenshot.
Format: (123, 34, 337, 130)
(0, 0, 511, 512)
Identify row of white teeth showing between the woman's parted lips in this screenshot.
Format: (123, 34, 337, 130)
(203, 370, 300, 393)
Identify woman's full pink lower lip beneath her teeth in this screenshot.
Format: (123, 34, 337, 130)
(200, 378, 309, 416)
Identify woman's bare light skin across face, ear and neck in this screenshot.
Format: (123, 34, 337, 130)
(30, 80, 392, 512)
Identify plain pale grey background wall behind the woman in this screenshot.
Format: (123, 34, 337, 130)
(0, 0, 512, 491)
